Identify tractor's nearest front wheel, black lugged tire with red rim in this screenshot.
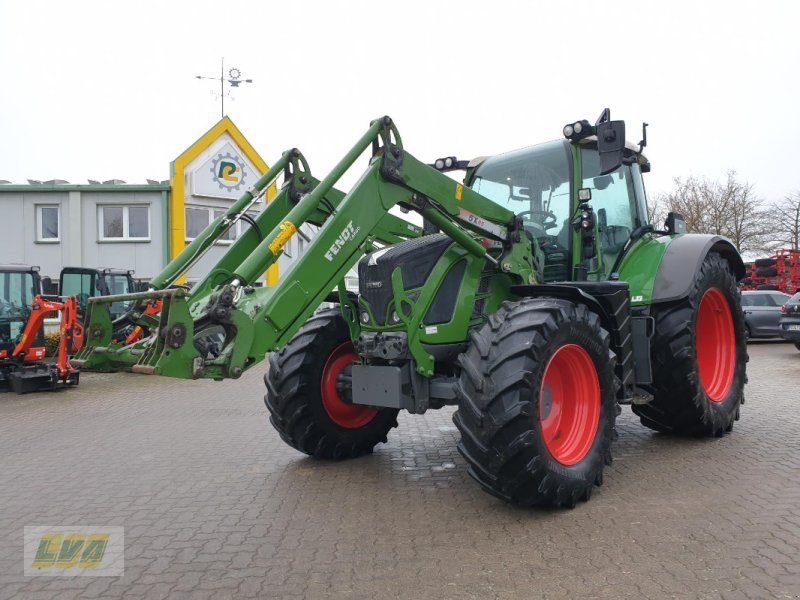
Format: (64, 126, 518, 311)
(453, 298, 617, 508)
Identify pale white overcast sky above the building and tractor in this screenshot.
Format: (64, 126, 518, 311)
(0, 0, 800, 200)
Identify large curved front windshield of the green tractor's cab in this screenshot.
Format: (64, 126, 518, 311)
(472, 140, 571, 281)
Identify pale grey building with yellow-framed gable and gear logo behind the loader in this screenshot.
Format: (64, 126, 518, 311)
(0, 117, 314, 284)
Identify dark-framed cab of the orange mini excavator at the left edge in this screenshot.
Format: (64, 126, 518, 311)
(0, 265, 44, 360)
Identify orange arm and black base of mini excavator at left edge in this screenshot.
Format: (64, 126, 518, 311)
(0, 294, 83, 394)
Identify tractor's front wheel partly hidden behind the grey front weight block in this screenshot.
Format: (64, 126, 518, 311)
(264, 309, 399, 460)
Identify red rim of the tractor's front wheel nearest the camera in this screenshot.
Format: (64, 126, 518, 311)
(539, 344, 600, 465)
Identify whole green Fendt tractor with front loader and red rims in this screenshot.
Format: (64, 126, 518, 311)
(74, 109, 747, 507)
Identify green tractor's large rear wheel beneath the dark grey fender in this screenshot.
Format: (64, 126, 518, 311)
(632, 252, 748, 436)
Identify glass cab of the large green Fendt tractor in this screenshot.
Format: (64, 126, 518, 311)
(467, 121, 649, 282)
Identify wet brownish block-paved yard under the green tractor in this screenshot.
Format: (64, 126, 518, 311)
(0, 343, 800, 600)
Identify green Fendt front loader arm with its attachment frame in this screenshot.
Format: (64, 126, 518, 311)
(77, 117, 536, 379)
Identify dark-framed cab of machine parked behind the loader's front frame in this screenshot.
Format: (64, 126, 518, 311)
(59, 267, 136, 320)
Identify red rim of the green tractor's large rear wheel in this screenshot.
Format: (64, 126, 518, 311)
(695, 288, 736, 402)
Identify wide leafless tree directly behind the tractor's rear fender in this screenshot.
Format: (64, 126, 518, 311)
(654, 171, 774, 252)
